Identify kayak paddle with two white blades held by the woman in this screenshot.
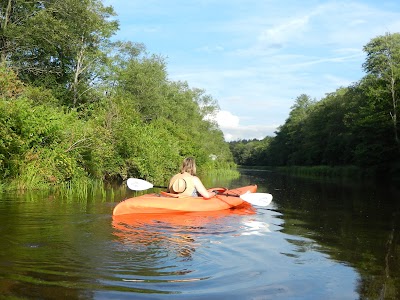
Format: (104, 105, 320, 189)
(126, 178, 273, 206)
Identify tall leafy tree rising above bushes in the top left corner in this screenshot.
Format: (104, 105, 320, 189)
(0, 0, 118, 106)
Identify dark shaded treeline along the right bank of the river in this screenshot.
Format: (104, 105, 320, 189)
(230, 33, 400, 176)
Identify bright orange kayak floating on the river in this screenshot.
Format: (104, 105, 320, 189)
(113, 185, 257, 216)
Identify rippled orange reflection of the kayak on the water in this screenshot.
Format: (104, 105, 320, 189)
(112, 204, 255, 259)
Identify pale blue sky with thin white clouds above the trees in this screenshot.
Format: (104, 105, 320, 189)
(103, 0, 400, 141)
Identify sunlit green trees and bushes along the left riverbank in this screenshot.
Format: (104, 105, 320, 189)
(0, 0, 235, 189)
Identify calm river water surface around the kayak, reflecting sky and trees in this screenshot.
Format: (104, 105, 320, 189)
(0, 170, 400, 299)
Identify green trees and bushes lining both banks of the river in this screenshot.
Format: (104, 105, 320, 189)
(0, 0, 400, 190)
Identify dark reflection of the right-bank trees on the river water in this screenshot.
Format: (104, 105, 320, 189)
(242, 170, 400, 299)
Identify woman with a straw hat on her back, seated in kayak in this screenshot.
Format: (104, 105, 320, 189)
(168, 157, 217, 199)
